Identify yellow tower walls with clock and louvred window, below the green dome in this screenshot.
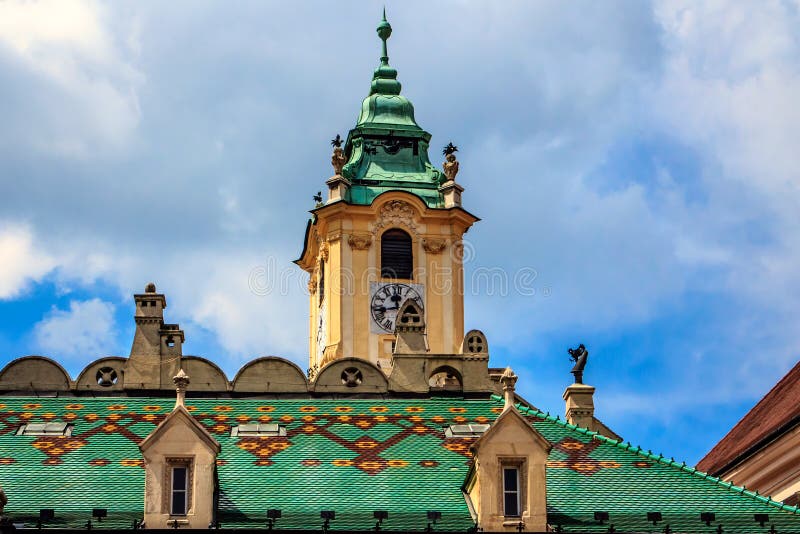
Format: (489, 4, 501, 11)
(298, 191, 476, 376)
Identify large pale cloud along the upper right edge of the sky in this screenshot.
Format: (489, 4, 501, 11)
(649, 1, 800, 330)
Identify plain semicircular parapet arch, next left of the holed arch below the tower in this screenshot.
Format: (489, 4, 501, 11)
(233, 356, 308, 393)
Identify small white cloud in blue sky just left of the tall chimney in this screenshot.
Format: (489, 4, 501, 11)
(33, 298, 116, 364)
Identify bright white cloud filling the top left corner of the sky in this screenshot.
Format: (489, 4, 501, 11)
(0, 0, 144, 157)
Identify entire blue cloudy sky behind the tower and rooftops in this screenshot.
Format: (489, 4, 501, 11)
(0, 0, 800, 462)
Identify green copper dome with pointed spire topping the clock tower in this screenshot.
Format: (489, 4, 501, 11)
(342, 11, 445, 208)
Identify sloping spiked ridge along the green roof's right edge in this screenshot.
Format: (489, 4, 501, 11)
(492, 395, 800, 515)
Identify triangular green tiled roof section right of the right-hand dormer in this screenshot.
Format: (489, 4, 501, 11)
(520, 407, 800, 533)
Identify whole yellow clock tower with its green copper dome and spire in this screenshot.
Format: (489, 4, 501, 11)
(296, 13, 478, 375)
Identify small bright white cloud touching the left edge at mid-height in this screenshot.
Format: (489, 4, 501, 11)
(0, 226, 55, 299)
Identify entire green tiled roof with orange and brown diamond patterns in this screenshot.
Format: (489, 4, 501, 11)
(0, 397, 800, 532)
